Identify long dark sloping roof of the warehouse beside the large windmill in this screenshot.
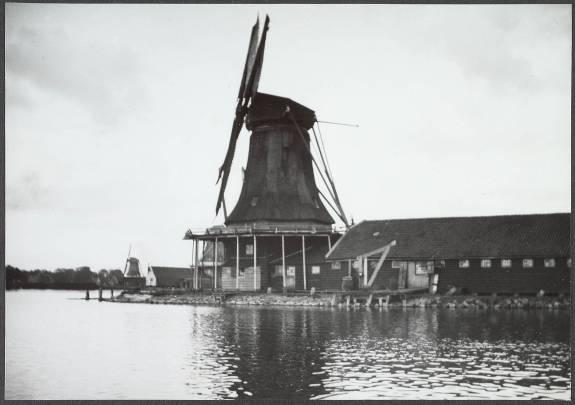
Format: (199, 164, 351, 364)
(327, 213, 571, 260)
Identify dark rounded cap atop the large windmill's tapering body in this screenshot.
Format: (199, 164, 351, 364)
(246, 93, 316, 131)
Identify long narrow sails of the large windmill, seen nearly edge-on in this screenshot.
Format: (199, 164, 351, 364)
(216, 16, 270, 215)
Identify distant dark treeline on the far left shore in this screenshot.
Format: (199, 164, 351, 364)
(6, 265, 124, 290)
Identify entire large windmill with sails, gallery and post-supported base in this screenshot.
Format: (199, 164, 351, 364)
(186, 16, 348, 290)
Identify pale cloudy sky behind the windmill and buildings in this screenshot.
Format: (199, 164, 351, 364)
(5, 4, 572, 271)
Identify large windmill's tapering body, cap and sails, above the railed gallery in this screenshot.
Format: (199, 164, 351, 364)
(216, 16, 348, 226)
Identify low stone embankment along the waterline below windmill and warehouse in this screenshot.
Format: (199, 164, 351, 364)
(110, 292, 570, 310)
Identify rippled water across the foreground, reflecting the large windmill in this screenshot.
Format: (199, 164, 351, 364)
(5, 291, 571, 400)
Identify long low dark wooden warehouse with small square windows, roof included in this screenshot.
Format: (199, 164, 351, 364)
(327, 213, 571, 293)
